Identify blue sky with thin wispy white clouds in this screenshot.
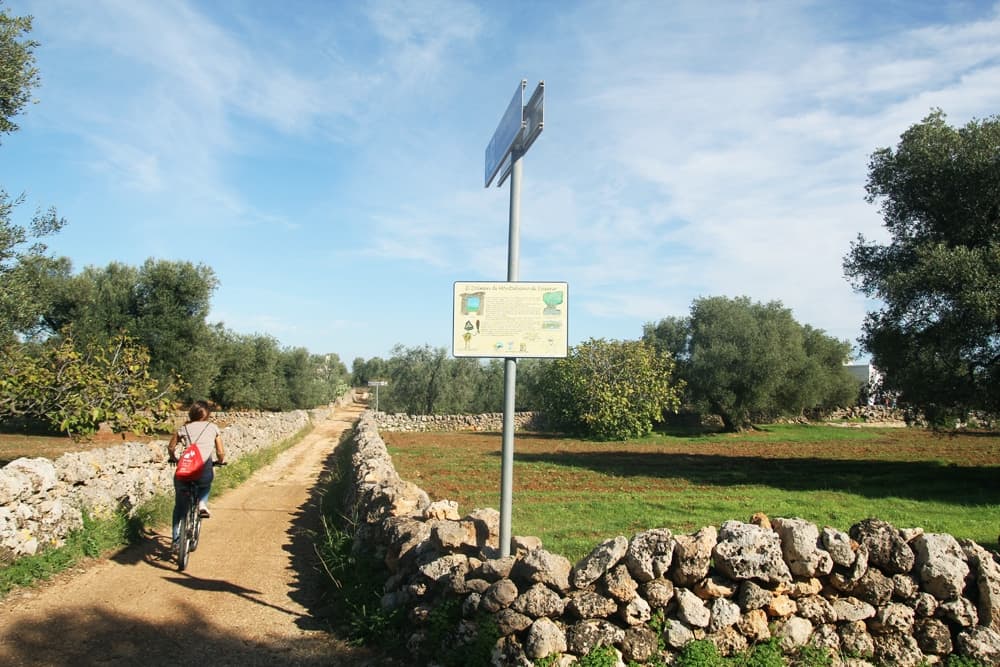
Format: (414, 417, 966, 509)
(0, 0, 1000, 366)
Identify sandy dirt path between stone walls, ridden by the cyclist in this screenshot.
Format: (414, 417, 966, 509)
(0, 406, 392, 667)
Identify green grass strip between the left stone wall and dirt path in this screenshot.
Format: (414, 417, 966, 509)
(0, 424, 313, 598)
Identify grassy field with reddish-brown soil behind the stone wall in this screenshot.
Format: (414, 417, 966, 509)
(382, 425, 1000, 562)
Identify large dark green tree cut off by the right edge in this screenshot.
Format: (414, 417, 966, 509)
(844, 110, 1000, 421)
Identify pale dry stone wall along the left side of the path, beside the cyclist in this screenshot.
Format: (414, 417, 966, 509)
(0, 395, 351, 564)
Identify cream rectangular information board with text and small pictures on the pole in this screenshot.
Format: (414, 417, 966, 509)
(452, 282, 569, 358)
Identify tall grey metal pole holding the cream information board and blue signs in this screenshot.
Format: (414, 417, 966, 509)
(500, 148, 522, 557)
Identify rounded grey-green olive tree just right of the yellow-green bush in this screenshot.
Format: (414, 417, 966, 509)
(643, 297, 858, 431)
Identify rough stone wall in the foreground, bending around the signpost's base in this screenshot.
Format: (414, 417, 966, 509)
(351, 413, 1000, 667)
